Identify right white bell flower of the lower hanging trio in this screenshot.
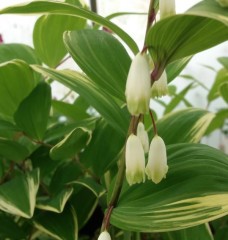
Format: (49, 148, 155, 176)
(145, 135, 168, 184)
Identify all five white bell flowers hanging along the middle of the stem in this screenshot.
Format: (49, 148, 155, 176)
(125, 49, 168, 185)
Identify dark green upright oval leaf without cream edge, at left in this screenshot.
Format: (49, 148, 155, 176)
(14, 82, 51, 140)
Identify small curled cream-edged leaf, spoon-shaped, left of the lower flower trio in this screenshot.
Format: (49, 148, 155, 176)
(50, 128, 91, 160)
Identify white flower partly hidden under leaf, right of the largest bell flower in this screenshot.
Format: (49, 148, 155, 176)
(151, 71, 169, 98)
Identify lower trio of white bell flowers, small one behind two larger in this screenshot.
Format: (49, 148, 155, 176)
(125, 123, 168, 185)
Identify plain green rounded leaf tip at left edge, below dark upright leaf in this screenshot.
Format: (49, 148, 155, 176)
(0, 138, 29, 162)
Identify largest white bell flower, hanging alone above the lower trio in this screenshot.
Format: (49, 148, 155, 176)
(125, 53, 150, 116)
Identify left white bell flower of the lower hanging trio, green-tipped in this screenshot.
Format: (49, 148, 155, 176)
(125, 134, 145, 185)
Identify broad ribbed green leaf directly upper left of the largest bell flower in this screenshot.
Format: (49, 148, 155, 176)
(64, 29, 131, 101)
